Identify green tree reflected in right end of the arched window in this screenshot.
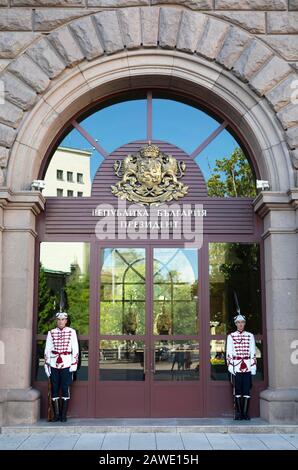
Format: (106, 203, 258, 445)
(207, 147, 256, 198)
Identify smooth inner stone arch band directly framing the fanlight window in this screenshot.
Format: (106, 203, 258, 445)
(7, 50, 293, 190)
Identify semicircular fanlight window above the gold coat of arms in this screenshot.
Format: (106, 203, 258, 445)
(42, 91, 256, 197)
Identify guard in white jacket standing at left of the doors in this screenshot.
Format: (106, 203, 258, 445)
(44, 312, 79, 421)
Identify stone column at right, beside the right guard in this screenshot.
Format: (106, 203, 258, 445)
(255, 189, 298, 424)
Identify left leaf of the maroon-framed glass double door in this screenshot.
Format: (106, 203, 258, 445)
(96, 247, 149, 417)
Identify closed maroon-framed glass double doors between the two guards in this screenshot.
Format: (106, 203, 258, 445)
(96, 247, 201, 417)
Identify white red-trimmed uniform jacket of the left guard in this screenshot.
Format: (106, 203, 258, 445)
(44, 326, 79, 372)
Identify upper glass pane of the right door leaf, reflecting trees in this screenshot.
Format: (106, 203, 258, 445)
(153, 248, 198, 335)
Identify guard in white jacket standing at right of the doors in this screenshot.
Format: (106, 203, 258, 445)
(227, 315, 257, 420)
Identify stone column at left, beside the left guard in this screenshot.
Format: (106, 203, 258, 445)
(0, 188, 44, 425)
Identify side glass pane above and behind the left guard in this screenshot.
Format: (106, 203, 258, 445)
(37, 242, 90, 335)
